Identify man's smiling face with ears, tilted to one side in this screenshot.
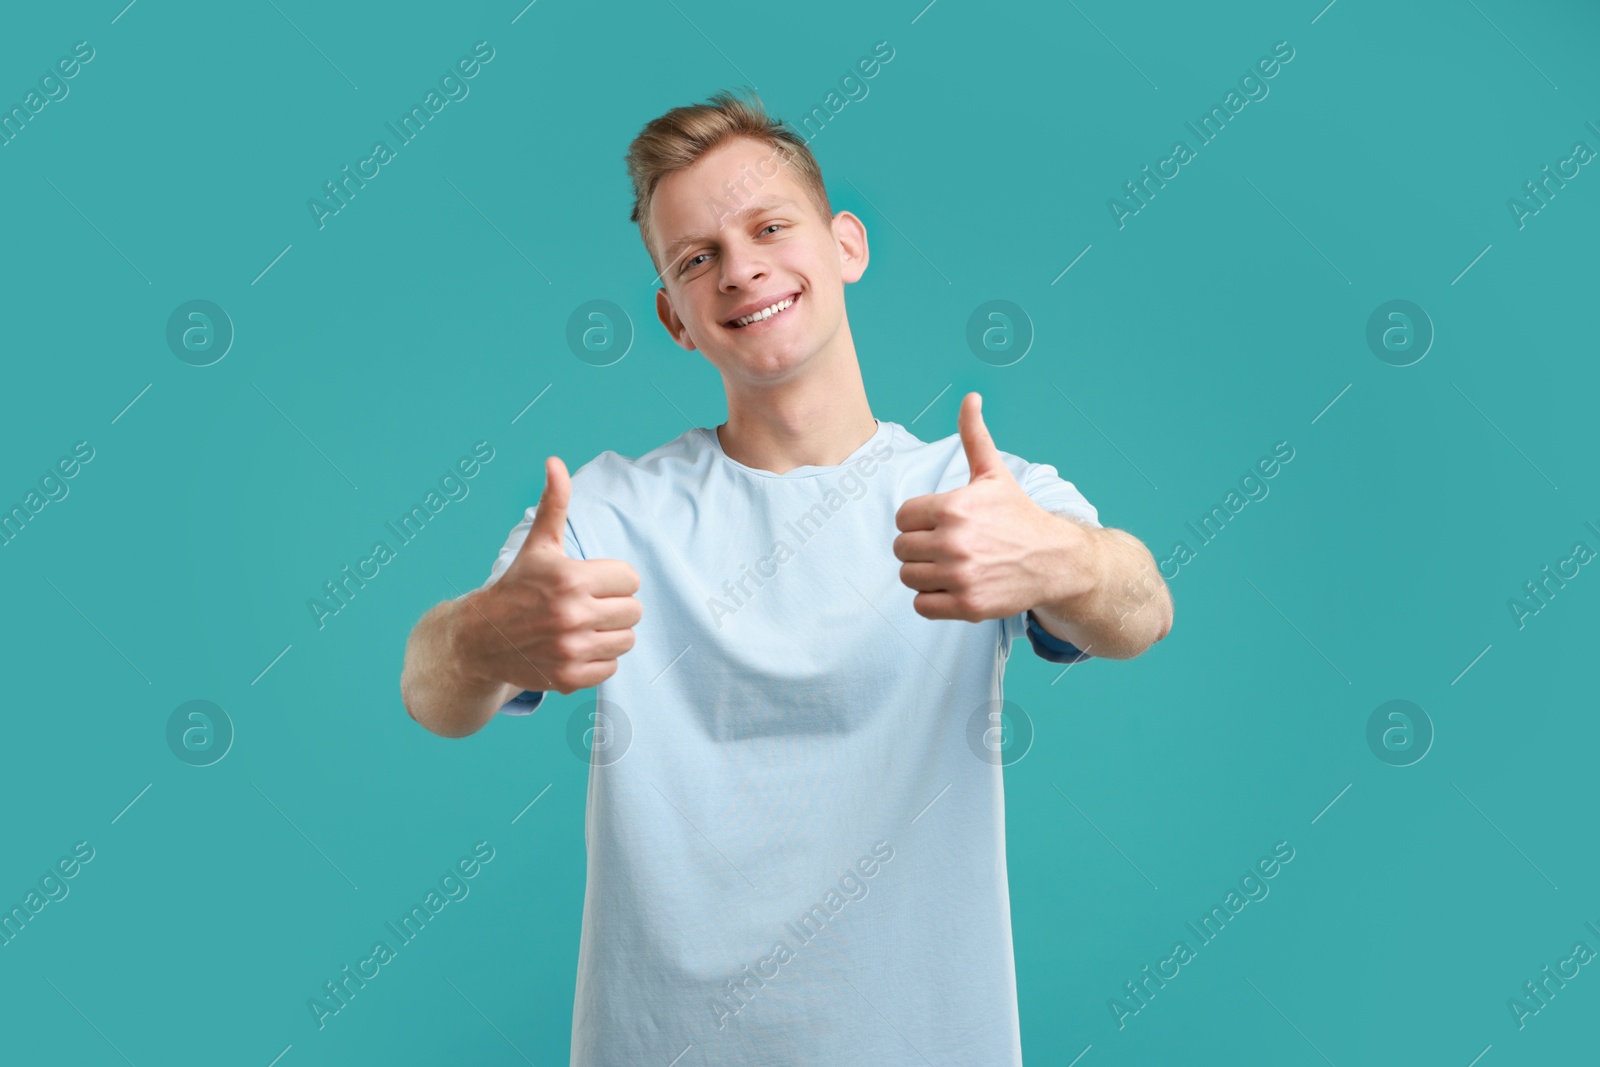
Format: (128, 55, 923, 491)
(651, 138, 867, 384)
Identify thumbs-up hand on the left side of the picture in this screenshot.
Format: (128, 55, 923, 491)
(451, 456, 643, 694)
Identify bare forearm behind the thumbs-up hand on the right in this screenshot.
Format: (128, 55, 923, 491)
(1034, 517, 1173, 659)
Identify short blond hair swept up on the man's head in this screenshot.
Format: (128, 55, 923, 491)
(624, 88, 834, 270)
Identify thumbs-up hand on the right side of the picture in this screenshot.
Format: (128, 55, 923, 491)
(894, 394, 1091, 622)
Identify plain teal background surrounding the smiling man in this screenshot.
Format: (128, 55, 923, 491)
(0, 0, 1600, 1067)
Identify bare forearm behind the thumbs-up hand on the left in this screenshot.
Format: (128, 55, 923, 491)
(400, 593, 522, 737)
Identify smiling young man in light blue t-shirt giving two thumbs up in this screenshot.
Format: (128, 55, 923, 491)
(402, 93, 1173, 1067)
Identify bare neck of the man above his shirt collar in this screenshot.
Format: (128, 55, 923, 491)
(717, 329, 878, 474)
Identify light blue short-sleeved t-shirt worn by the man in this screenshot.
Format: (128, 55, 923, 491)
(470, 421, 1101, 1067)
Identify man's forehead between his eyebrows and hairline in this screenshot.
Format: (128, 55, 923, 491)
(650, 138, 805, 256)
